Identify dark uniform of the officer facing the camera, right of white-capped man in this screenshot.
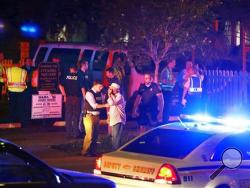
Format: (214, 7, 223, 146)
(138, 83, 161, 126)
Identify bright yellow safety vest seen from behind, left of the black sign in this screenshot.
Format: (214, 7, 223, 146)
(6, 67, 27, 92)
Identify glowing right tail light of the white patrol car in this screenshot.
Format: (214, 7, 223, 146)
(155, 164, 181, 184)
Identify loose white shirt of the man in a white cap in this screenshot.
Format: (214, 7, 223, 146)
(108, 93, 126, 126)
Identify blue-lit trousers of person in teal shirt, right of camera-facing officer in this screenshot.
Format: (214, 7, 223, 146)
(163, 91, 173, 123)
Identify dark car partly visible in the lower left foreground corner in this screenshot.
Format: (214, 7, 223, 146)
(0, 139, 115, 188)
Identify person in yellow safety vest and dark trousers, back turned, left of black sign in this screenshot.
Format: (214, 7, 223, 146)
(6, 67, 27, 125)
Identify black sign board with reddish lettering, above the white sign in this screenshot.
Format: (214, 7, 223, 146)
(38, 63, 59, 93)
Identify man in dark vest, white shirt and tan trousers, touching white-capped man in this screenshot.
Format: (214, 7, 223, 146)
(81, 81, 108, 157)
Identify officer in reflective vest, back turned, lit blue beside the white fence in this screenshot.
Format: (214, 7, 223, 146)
(182, 65, 204, 114)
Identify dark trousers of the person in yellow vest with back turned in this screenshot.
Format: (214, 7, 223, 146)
(9, 91, 25, 125)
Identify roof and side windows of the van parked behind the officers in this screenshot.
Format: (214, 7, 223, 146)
(33, 42, 126, 83)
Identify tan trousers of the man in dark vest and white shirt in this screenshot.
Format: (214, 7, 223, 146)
(81, 114, 99, 155)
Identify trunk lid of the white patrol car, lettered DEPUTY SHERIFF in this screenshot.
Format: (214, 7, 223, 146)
(101, 151, 184, 180)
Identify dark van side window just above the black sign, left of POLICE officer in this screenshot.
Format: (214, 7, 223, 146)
(48, 48, 81, 75)
